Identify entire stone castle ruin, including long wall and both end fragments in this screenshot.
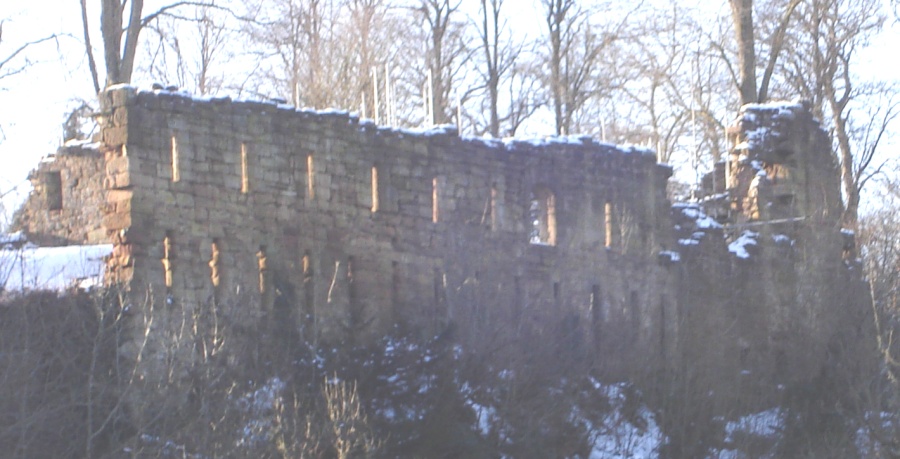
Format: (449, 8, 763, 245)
(10, 87, 871, 398)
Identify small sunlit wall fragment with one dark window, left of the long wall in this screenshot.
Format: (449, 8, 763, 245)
(11, 144, 108, 246)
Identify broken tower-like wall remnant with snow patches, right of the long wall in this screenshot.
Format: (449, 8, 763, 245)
(680, 103, 874, 394)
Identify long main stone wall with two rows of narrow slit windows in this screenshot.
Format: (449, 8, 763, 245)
(96, 88, 677, 370)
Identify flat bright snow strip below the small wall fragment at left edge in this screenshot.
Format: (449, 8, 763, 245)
(0, 244, 112, 291)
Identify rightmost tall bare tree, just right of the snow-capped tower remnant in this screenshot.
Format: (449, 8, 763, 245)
(783, 0, 898, 228)
